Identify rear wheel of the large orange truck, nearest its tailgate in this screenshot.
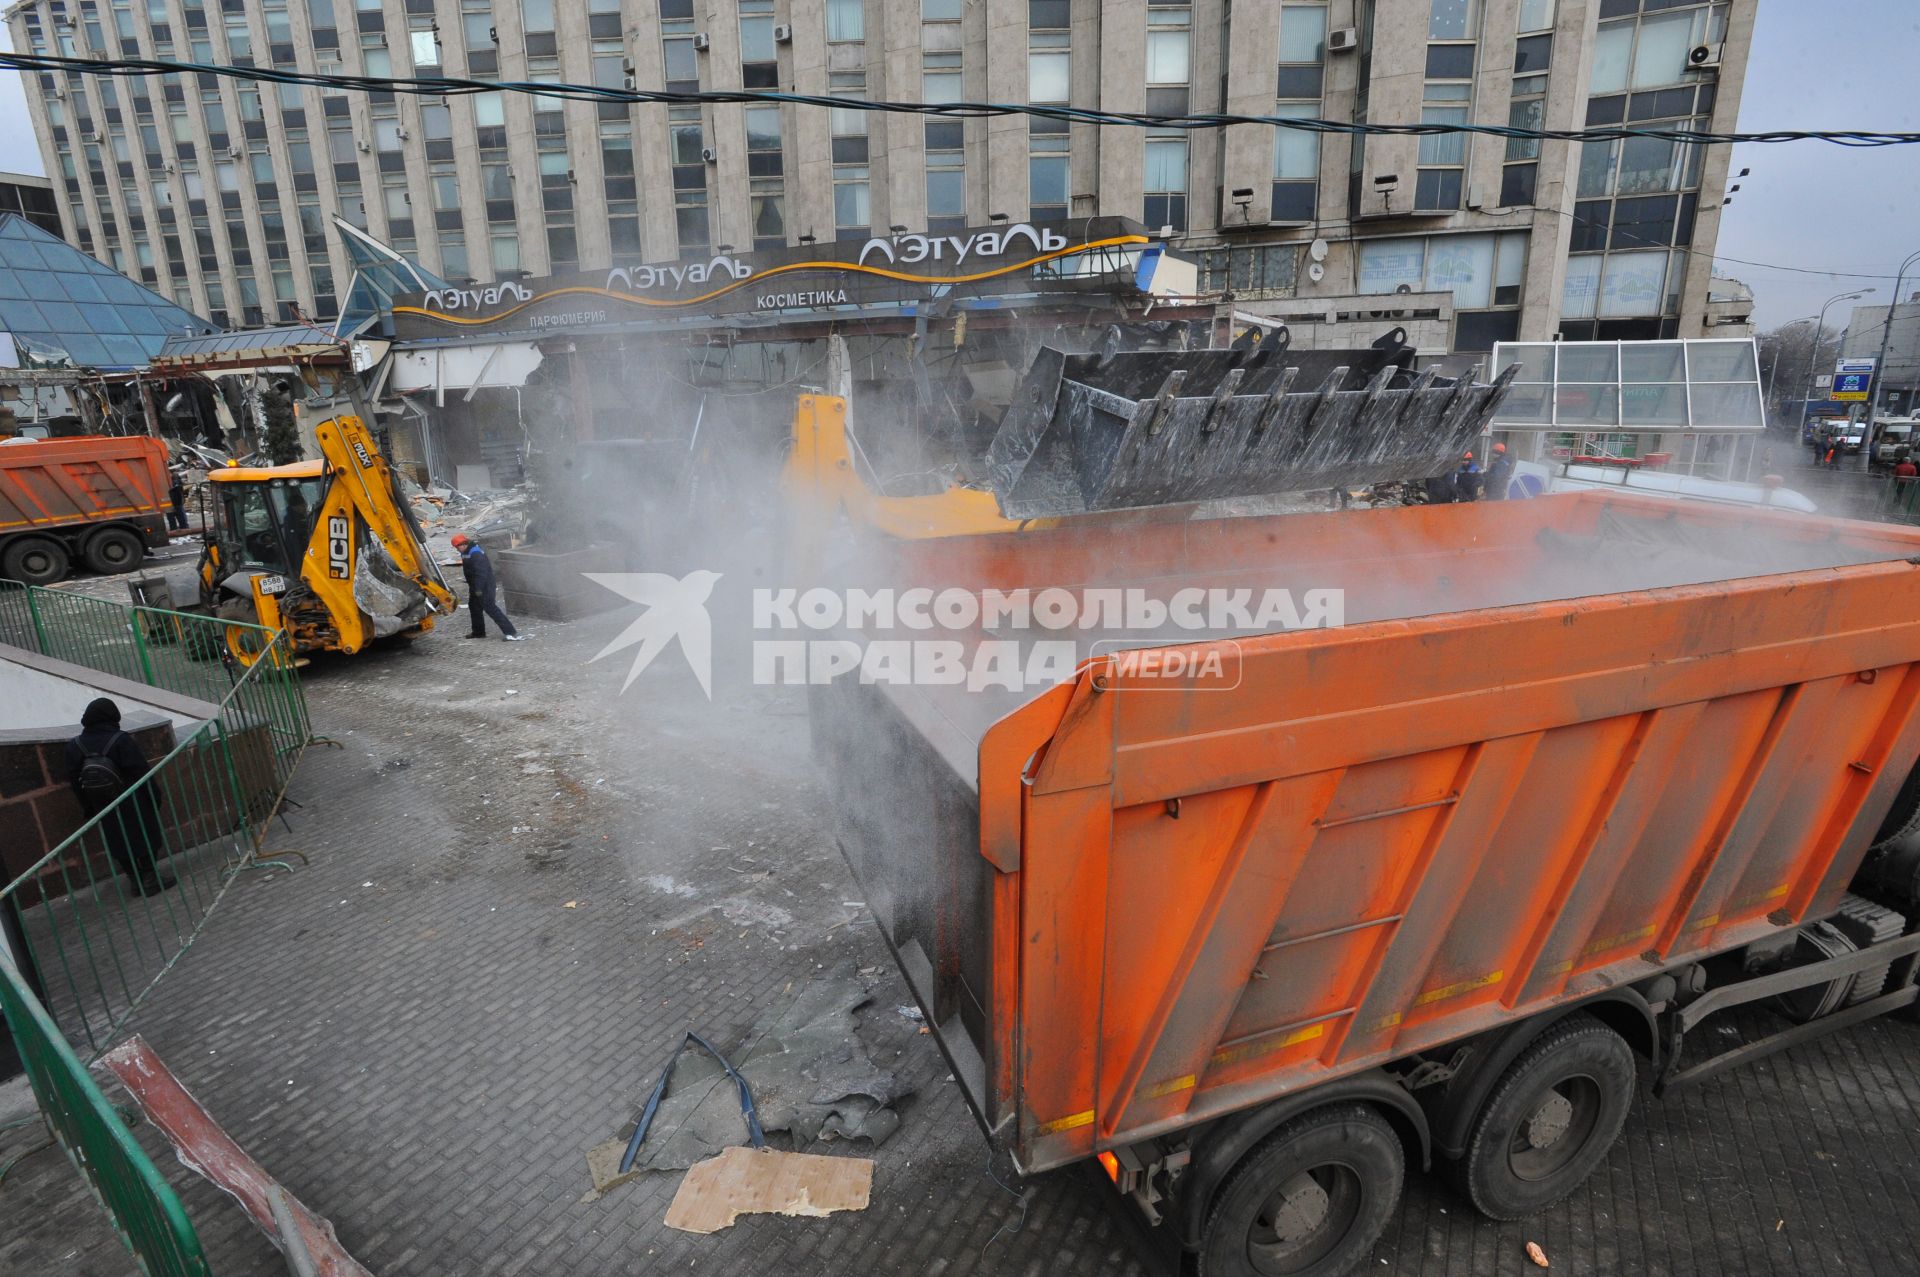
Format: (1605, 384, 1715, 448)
(1200, 1104, 1407, 1277)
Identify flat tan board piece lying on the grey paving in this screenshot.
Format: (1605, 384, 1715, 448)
(666, 1148, 874, 1233)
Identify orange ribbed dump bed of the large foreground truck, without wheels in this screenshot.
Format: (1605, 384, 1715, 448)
(814, 494, 1920, 1169)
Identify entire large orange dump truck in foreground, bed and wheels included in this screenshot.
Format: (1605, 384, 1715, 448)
(812, 494, 1920, 1277)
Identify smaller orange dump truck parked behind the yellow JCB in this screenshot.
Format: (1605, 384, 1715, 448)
(0, 434, 167, 586)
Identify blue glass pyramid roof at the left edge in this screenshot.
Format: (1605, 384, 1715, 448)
(0, 213, 219, 369)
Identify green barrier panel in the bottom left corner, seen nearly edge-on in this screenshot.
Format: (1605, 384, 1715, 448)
(0, 947, 209, 1277)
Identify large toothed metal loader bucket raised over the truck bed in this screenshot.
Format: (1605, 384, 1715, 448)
(987, 328, 1513, 518)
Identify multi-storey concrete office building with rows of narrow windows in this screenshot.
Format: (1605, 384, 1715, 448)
(8, 0, 1757, 349)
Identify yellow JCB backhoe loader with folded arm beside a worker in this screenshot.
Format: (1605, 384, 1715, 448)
(200, 417, 459, 664)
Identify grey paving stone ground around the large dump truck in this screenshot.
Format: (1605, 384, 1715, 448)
(11, 611, 1920, 1277)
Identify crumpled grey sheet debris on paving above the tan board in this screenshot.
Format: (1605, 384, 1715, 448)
(588, 962, 912, 1196)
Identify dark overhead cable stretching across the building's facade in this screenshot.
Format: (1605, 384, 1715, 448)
(11, 54, 1920, 146)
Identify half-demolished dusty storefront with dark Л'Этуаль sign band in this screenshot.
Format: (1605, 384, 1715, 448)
(384, 217, 1215, 486)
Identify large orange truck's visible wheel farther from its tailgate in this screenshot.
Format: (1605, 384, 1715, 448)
(1455, 1012, 1634, 1219)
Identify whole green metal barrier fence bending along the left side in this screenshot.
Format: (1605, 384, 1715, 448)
(0, 582, 311, 1277)
